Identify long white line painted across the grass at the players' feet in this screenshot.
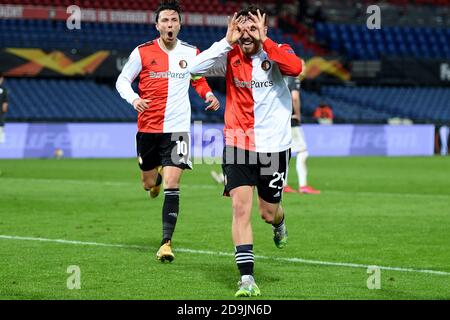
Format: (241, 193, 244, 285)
(0, 235, 450, 276)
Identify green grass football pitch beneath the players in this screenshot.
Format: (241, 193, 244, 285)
(0, 157, 450, 300)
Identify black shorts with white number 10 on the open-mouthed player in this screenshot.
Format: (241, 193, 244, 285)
(136, 132, 192, 171)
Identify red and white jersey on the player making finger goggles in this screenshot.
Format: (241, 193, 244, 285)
(188, 39, 302, 152)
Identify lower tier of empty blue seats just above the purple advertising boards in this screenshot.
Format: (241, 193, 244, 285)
(6, 79, 450, 123)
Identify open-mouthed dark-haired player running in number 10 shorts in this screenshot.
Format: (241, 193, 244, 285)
(116, 1, 219, 262)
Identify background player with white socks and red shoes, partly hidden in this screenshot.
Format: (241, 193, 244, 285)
(283, 67, 320, 194)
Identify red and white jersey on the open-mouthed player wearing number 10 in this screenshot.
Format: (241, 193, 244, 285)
(116, 39, 211, 133)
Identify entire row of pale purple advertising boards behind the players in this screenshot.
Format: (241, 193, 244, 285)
(0, 122, 435, 159)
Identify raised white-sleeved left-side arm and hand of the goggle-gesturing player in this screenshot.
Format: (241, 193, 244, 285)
(189, 13, 242, 76)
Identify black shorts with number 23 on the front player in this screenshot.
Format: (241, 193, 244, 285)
(222, 146, 291, 203)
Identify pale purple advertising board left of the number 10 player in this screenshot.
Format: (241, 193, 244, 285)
(0, 123, 136, 158)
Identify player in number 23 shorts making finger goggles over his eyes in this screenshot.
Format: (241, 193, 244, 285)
(189, 6, 302, 297)
